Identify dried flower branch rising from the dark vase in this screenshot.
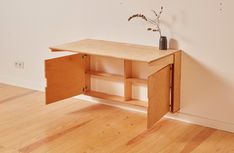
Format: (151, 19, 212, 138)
(128, 6, 163, 37)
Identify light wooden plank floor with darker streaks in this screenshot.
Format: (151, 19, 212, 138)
(0, 84, 234, 153)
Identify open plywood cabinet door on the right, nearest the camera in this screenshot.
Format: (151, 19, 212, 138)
(147, 65, 171, 128)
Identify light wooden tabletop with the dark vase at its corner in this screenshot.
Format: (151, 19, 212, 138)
(50, 39, 179, 63)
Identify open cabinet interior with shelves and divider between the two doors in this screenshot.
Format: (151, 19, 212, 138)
(85, 56, 149, 107)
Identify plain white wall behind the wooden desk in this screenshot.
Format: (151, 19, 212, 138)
(0, 0, 234, 132)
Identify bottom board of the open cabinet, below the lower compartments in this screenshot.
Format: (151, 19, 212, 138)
(85, 91, 148, 107)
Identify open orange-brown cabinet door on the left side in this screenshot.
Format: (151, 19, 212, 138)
(45, 54, 85, 104)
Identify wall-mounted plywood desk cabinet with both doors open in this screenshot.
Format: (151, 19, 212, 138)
(45, 39, 181, 128)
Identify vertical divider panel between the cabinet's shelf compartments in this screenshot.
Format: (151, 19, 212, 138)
(124, 60, 132, 101)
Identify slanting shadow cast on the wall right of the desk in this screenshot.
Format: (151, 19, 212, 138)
(181, 52, 234, 123)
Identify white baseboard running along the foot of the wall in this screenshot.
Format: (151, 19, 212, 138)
(0, 75, 234, 133)
